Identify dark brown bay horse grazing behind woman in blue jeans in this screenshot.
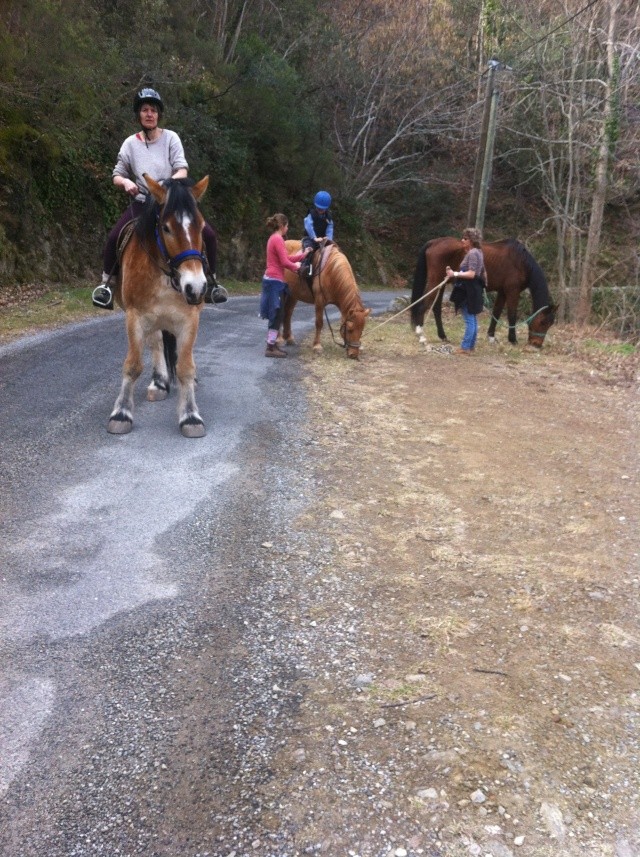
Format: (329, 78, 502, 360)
(411, 238, 557, 348)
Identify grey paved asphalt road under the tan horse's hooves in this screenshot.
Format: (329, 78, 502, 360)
(0, 293, 398, 857)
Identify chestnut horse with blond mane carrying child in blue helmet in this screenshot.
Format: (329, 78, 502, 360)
(282, 241, 371, 360)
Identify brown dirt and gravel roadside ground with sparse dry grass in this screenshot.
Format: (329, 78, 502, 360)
(260, 316, 640, 857)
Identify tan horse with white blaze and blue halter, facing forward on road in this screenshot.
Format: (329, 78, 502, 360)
(107, 173, 209, 437)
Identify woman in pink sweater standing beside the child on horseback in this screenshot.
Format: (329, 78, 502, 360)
(260, 214, 307, 357)
